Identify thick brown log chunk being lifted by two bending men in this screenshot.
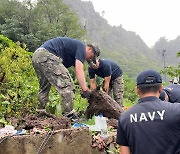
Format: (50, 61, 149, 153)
(85, 90, 124, 119)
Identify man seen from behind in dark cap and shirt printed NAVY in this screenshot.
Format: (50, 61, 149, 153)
(116, 70, 180, 154)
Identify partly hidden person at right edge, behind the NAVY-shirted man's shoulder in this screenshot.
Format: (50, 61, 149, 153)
(159, 84, 180, 103)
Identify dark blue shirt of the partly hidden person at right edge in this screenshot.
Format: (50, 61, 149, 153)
(163, 84, 180, 103)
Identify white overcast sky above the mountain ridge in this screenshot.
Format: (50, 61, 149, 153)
(82, 0, 180, 47)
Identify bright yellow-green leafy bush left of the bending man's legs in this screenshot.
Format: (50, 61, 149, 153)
(0, 35, 37, 117)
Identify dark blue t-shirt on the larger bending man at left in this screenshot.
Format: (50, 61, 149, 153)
(41, 37, 86, 68)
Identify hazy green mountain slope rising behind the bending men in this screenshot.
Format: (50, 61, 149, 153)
(63, 0, 158, 77)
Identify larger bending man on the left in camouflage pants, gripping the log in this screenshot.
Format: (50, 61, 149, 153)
(32, 37, 100, 115)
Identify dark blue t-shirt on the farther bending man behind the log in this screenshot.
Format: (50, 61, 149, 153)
(88, 59, 122, 81)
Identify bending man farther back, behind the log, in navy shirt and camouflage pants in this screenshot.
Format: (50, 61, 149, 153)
(88, 59, 124, 107)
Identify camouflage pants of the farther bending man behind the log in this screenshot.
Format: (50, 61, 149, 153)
(108, 76, 124, 107)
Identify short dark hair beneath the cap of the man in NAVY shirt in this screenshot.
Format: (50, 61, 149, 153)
(137, 83, 162, 94)
